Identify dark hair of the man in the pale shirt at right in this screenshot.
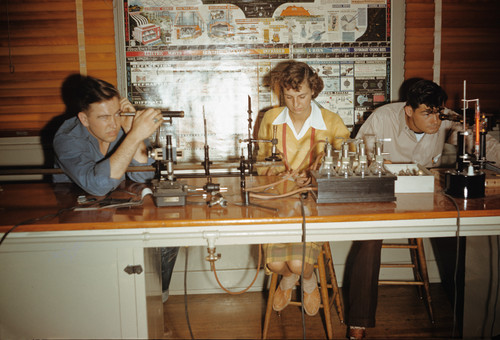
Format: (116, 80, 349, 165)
(406, 79, 448, 110)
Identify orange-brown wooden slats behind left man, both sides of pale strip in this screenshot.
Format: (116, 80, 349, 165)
(0, 0, 117, 136)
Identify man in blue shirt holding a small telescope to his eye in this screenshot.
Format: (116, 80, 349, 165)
(53, 76, 179, 300)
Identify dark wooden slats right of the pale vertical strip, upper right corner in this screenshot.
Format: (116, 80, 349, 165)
(441, 0, 500, 115)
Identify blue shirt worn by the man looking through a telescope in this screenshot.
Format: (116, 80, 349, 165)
(53, 117, 154, 196)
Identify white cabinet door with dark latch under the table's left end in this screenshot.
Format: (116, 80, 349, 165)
(0, 240, 163, 339)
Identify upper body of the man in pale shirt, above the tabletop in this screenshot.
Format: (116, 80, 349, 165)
(356, 80, 500, 167)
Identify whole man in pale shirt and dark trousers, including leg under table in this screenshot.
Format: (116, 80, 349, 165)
(344, 79, 500, 339)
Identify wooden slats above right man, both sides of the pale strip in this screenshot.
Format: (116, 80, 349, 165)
(405, 0, 500, 123)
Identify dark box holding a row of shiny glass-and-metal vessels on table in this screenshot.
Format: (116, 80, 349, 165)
(312, 139, 396, 203)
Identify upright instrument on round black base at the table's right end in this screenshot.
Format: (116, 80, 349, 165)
(441, 81, 488, 198)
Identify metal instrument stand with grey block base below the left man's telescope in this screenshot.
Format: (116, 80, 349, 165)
(149, 111, 187, 207)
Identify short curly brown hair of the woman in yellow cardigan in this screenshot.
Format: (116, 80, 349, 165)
(271, 60, 324, 98)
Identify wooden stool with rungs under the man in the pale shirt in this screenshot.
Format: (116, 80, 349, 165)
(378, 238, 434, 323)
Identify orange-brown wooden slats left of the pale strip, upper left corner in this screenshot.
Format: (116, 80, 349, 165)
(0, 0, 78, 135)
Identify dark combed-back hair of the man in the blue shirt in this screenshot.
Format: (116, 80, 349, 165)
(62, 74, 120, 114)
